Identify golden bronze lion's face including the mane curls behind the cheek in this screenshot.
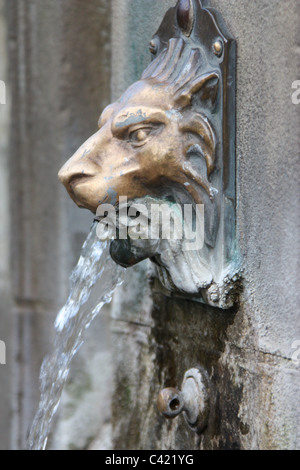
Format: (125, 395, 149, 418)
(59, 75, 215, 212)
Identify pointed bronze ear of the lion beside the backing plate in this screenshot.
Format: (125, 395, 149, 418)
(175, 72, 219, 108)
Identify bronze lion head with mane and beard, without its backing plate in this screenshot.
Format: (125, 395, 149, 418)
(59, 0, 237, 308)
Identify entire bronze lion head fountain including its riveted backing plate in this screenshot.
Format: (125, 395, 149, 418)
(59, 0, 237, 308)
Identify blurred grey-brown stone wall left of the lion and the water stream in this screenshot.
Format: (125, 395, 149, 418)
(1, 0, 110, 449)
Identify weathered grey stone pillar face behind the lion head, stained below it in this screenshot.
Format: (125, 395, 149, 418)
(112, 0, 300, 449)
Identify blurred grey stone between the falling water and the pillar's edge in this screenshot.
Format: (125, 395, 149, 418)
(52, 307, 113, 450)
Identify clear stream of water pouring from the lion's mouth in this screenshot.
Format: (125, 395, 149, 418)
(28, 222, 125, 450)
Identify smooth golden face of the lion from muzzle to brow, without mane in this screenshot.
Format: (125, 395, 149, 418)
(59, 81, 182, 212)
